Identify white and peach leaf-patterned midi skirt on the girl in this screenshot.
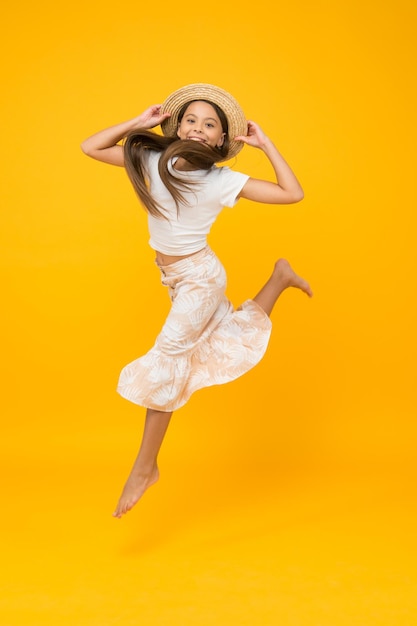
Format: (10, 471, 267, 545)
(117, 247, 271, 411)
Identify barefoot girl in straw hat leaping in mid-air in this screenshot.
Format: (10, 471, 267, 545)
(82, 83, 312, 518)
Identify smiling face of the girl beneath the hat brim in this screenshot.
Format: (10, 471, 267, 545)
(177, 100, 226, 148)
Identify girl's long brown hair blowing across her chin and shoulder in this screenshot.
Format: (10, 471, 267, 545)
(124, 100, 229, 219)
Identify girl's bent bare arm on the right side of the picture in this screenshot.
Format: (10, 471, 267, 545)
(235, 122, 304, 204)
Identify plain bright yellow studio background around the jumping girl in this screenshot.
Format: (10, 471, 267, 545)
(0, 0, 417, 626)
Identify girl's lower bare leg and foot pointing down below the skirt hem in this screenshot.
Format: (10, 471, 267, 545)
(113, 409, 172, 518)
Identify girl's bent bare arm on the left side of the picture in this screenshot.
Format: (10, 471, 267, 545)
(81, 104, 170, 167)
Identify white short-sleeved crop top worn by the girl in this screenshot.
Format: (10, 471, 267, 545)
(144, 150, 249, 256)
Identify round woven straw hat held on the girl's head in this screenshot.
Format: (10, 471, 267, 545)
(161, 83, 244, 161)
